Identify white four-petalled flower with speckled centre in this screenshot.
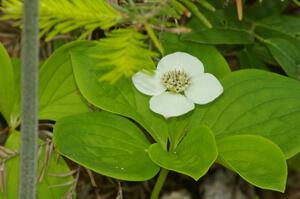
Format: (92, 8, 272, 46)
(132, 52, 223, 118)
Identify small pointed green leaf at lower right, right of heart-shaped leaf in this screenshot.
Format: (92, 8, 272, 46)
(217, 135, 287, 192)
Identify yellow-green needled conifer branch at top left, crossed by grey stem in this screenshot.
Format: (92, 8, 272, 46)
(1, 0, 123, 40)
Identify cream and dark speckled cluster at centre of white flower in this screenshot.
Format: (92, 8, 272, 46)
(161, 70, 191, 93)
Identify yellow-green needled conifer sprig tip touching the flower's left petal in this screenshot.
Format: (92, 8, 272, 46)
(95, 28, 158, 83)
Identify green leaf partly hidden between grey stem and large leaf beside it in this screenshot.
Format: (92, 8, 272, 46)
(39, 41, 93, 120)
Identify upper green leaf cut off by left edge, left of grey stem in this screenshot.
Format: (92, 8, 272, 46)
(0, 43, 17, 124)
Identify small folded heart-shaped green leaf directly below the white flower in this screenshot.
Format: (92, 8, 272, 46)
(149, 125, 218, 180)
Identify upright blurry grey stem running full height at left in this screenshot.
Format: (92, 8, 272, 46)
(19, 0, 39, 199)
